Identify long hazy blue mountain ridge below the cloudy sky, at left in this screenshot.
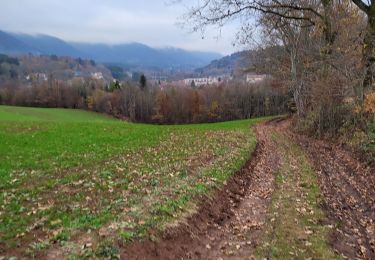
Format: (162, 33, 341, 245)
(0, 31, 222, 69)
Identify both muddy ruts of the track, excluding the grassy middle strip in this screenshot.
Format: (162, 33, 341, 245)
(121, 119, 375, 259)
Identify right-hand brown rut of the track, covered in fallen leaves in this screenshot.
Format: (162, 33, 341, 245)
(289, 123, 375, 259)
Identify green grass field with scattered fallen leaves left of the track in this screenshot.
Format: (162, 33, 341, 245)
(0, 106, 263, 257)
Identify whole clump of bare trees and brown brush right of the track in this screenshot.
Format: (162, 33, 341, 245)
(176, 0, 375, 136)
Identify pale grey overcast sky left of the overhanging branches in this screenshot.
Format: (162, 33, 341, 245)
(0, 0, 244, 54)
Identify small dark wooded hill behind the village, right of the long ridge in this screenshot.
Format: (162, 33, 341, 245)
(195, 51, 251, 76)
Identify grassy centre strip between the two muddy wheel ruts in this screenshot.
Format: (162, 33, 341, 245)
(256, 133, 339, 259)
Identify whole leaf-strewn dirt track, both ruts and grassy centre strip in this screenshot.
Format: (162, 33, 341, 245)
(121, 120, 375, 259)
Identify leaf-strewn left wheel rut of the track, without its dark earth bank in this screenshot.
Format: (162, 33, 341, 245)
(184, 125, 279, 259)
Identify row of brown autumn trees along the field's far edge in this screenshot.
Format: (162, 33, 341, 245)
(0, 77, 288, 124)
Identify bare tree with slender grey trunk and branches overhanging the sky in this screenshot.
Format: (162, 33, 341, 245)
(178, 0, 335, 115)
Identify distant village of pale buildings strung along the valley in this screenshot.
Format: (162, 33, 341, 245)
(15, 53, 270, 88)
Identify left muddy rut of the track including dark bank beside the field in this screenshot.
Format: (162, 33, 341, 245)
(121, 123, 279, 259)
